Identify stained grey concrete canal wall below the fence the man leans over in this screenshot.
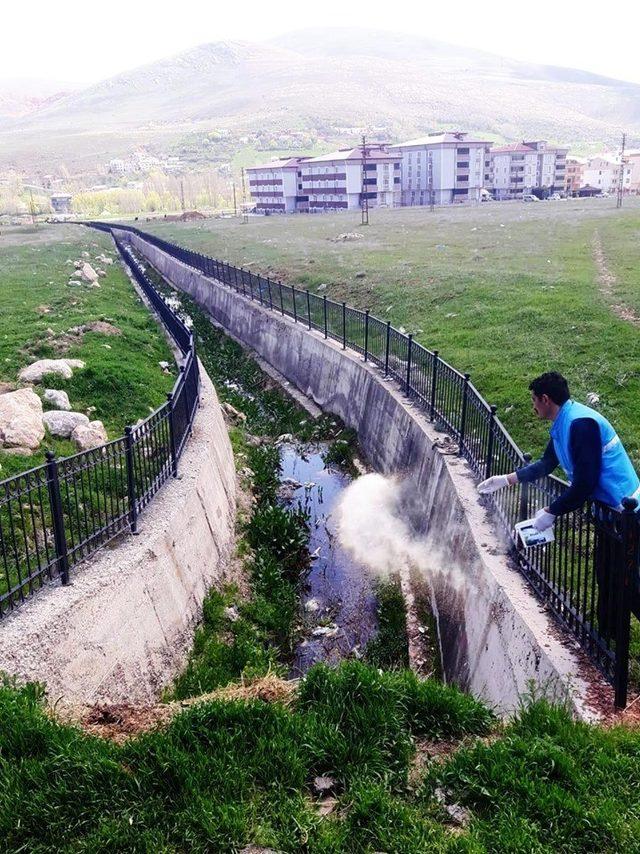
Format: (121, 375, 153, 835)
(127, 232, 609, 719)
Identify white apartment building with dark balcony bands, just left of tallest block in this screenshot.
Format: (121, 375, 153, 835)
(298, 143, 400, 213)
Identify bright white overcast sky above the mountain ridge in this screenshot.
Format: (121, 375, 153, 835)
(5, 0, 640, 85)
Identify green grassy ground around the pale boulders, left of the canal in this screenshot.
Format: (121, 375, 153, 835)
(0, 225, 175, 478)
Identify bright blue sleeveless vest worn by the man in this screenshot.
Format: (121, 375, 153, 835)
(551, 400, 640, 510)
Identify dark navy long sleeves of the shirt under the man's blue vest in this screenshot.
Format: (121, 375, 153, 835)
(516, 418, 602, 516)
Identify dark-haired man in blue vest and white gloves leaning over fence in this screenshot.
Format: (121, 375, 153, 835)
(478, 371, 640, 637)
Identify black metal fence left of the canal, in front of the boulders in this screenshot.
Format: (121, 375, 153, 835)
(0, 229, 200, 617)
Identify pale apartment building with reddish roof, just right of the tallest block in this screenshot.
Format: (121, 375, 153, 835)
(489, 140, 568, 199)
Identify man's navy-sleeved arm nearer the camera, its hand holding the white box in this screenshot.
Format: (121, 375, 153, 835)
(549, 418, 602, 516)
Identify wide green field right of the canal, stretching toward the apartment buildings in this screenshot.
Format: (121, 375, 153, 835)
(138, 199, 640, 464)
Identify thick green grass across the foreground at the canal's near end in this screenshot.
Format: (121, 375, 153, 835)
(6, 676, 640, 854)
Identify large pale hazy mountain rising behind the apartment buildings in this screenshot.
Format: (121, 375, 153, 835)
(0, 28, 640, 168)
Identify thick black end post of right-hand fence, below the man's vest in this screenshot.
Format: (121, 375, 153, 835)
(613, 498, 638, 709)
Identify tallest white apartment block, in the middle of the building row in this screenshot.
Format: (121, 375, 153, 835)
(389, 131, 490, 205)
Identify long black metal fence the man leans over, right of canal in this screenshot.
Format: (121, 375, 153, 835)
(96, 224, 639, 707)
